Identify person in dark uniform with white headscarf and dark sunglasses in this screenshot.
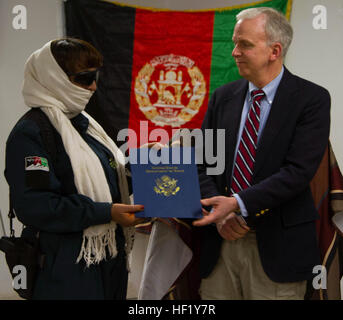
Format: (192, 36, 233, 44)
(5, 38, 143, 299)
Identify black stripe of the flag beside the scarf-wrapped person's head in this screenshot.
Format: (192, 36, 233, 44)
(65, 0, 136, 144)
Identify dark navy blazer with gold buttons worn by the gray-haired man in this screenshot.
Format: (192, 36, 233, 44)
(199, 68, 330, 282)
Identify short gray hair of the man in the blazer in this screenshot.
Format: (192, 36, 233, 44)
(236, 7, 293, 57)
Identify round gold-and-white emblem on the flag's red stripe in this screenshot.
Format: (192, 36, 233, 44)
(135, 54, 206, 127)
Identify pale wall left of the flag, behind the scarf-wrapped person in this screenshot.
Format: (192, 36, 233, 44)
(0, 0, 62, 299)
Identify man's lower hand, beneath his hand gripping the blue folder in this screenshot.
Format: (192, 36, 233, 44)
(217, 212, 250, 240)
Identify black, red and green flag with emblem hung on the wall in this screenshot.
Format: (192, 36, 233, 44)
(65, 0, 292, 147)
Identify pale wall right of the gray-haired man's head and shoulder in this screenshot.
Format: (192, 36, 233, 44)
(286, 0, 343, 170)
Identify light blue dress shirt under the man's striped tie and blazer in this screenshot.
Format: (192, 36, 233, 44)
(232, 66, 284, 217)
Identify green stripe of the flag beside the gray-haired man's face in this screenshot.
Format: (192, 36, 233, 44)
(209, 0, 291, 96)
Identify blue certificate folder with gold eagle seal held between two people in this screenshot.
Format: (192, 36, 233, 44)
(129, 147, 202, 218)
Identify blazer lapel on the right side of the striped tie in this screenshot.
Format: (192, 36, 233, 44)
(254, 68, 297, 176)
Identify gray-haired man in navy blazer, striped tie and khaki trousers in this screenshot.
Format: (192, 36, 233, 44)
(194, 8, 330, 299)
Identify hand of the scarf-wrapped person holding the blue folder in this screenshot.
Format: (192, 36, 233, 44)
(111, 203, 145, 227)
